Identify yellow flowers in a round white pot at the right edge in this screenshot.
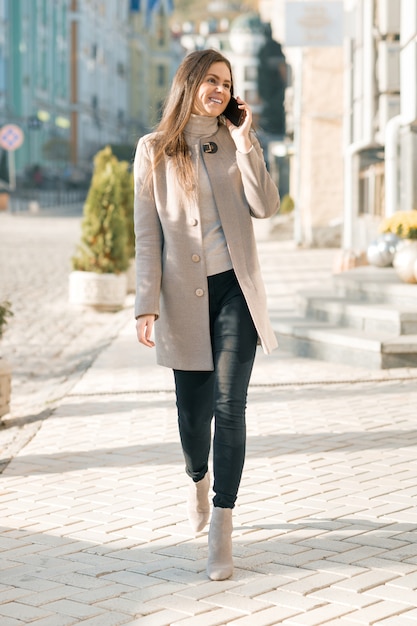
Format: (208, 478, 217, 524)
(379, 210, 417, 283)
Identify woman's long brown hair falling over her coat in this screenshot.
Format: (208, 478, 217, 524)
(147, 50, 233, 196)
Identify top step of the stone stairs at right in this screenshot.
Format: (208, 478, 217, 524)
(333, 265, 417, 310)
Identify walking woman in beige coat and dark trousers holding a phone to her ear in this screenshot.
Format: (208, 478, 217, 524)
(134, 50, 279, 580)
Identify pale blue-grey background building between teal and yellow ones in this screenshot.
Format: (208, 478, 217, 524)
(67, 0, 129, 166)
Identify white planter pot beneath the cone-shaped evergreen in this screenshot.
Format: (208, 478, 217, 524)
(69, 271, 127, 311)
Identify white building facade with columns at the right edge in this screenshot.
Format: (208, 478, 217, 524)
(343, 0, 417, 251)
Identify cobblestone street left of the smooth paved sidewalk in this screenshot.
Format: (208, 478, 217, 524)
(0, 209, 132, 469)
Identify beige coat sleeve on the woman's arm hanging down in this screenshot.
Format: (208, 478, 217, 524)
(133, 137, 163, 317)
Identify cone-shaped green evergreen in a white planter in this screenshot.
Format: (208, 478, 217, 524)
(69, 146, 129, 311)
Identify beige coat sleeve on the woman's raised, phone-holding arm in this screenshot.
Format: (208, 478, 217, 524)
(236, 133, 280, 218)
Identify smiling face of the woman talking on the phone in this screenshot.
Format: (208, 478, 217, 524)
(192, 61, 232, 117)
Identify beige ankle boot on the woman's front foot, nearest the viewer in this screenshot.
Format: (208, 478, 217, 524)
(207, 507, 233, 580)
